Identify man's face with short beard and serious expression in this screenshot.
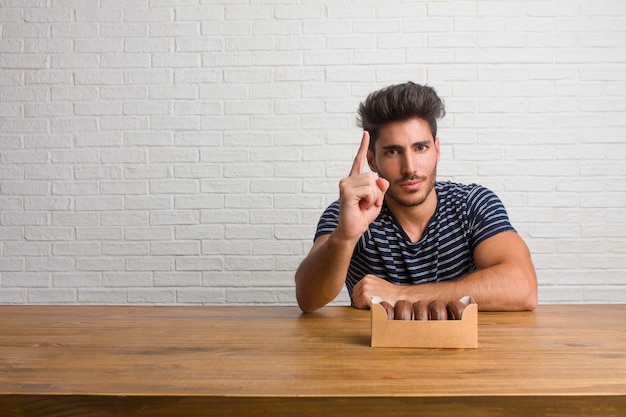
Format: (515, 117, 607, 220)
(367, 119, 439, 207)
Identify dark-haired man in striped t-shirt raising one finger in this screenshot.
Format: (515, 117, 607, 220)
(295, 82, 537, 312)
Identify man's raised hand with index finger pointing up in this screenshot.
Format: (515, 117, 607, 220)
(337, 131, 389, 240)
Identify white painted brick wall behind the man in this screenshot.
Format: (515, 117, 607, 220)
(0, 0, 626, 304)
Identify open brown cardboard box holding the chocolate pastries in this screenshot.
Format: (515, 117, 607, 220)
(371, 297, 478, 348)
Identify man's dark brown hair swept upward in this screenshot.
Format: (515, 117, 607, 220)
(358, 81, 446, 150)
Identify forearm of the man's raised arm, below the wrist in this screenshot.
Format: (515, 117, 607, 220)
(295, 233, 356, 313)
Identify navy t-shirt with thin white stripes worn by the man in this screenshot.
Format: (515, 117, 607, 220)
(315, 182, 514, 297)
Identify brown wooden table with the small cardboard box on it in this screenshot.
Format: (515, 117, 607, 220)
(0, 305, 626, 417)
